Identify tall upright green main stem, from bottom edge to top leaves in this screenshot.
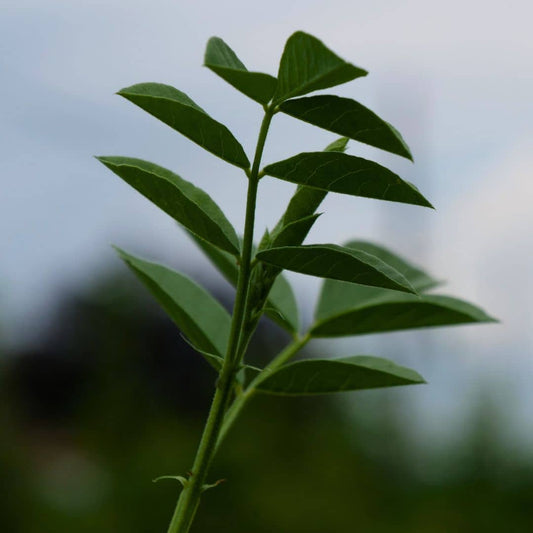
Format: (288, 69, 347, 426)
(168, 108, 274, 533)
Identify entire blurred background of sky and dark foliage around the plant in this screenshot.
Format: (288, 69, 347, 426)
(0, 0, 533, 533)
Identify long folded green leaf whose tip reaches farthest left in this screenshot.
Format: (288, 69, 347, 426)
(97, 156, 240, 255)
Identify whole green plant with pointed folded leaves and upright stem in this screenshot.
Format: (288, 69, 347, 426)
(98, 32, 493, 533)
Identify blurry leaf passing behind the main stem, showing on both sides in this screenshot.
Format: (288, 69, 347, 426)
(186, 233, 300, 333)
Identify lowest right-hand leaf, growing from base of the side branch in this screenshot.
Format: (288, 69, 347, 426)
(257, 355, 425, 395)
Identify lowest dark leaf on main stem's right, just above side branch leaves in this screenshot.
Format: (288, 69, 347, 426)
(257, 244, 415, 292)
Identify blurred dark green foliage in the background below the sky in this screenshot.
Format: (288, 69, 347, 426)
(0, 276, 533, 533)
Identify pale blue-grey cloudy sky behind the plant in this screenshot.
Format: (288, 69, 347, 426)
(0, 0, 533, 454)
